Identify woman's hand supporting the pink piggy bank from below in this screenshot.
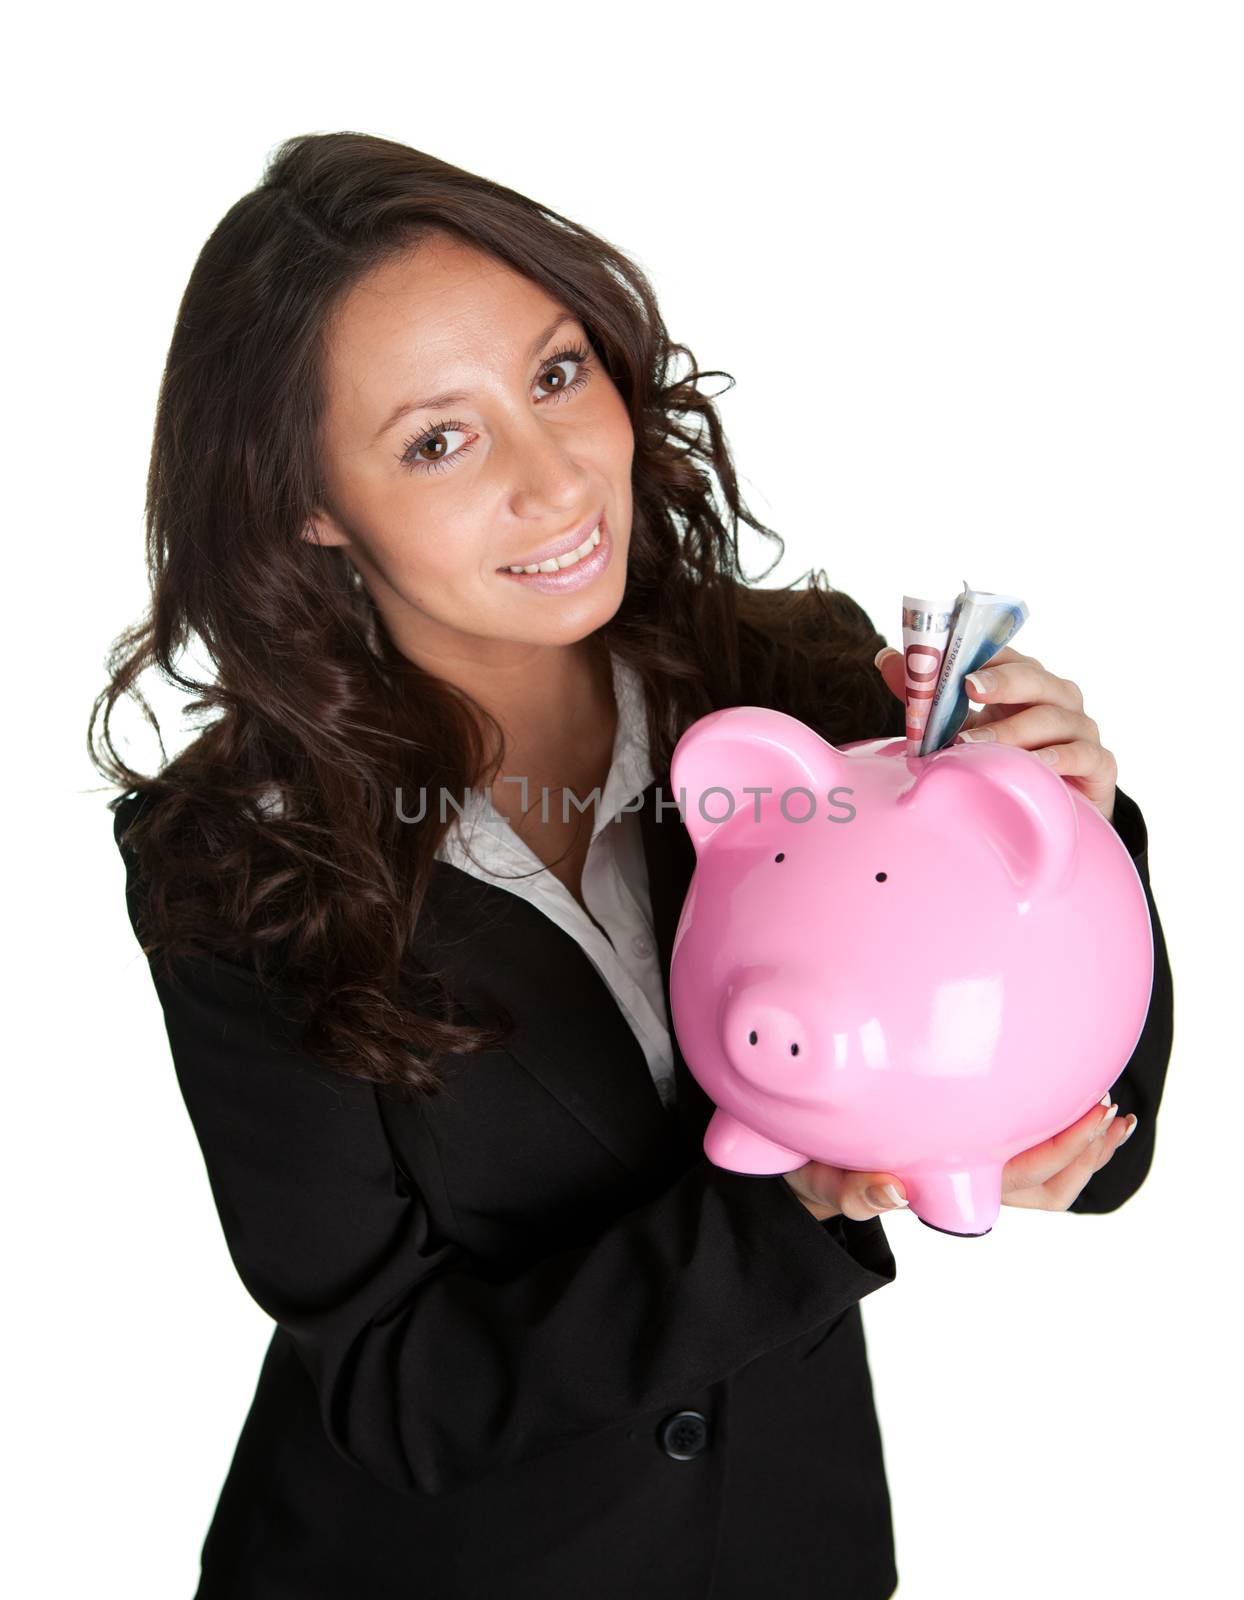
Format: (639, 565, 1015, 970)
(782, 1094, 1137, 1222)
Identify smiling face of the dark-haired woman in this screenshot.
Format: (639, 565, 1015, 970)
(304, 235, 635, 675)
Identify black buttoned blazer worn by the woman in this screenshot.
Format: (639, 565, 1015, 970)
(115, 779, 1172, 1600)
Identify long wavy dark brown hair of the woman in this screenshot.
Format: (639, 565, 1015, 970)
(88, 133, 902, 1093)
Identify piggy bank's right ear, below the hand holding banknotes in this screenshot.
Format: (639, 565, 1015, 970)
(897, 744, 1079, 901)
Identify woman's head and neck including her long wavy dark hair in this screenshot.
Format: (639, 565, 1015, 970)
(91, 133, 895, 1091)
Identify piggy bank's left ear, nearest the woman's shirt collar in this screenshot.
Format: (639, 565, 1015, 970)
(670, 706, 851, 854)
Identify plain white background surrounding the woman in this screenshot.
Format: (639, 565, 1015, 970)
(12, 0, 1244, 1600)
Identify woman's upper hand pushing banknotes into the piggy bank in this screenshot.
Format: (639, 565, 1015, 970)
(876, 645, 1118, 822)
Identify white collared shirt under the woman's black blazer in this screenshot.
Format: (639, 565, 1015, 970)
(437, 651, 675, 1109)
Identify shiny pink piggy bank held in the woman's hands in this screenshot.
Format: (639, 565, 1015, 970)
(670, 706, 1153, 1235)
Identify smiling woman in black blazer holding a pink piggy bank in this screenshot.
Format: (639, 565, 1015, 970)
(93, 134, 1169, 1600)
